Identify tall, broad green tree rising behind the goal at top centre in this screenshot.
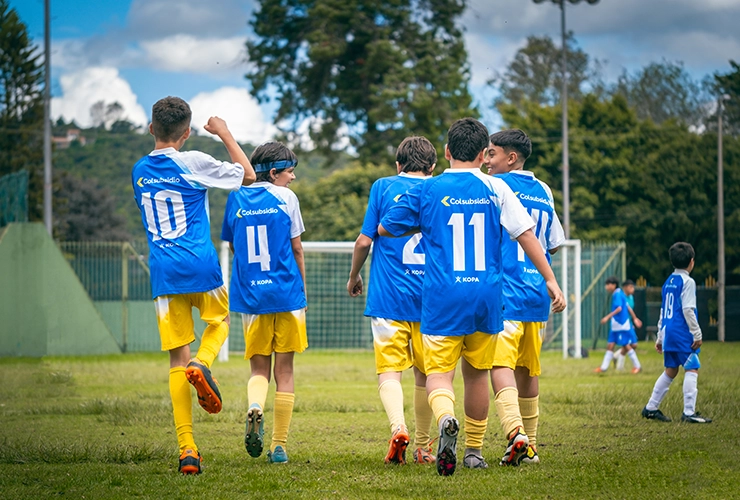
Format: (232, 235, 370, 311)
(247, 0, 476, 162)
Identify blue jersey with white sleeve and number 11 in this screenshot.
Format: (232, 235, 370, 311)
(381, 169, 534, 336)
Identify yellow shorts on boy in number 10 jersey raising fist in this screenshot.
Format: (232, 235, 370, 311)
(154, 285, 229, 351)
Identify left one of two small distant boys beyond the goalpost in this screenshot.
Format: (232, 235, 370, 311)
(594, 276, 642, 373)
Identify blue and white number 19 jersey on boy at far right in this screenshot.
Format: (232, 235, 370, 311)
(658, 269, 696, 352)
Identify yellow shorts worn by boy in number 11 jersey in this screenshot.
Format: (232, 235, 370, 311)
(422, 332, 496, 375)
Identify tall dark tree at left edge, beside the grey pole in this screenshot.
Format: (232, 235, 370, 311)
(0, 0, 44, 220)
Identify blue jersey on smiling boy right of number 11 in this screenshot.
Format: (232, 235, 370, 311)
(496, 170, 565, 322)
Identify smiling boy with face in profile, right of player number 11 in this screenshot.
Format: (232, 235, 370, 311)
(486, 129, 565, 466)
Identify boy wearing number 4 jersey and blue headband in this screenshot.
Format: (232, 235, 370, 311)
(221, 142, 308, 463)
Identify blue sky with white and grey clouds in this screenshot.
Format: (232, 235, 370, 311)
(10, 0, 740, 143)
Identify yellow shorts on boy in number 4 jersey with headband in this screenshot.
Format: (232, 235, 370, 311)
(242, 308, 308, 359)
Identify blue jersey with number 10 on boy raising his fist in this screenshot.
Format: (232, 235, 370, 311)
(131, 148, 244, 298)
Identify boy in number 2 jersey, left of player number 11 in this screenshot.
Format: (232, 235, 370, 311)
(347, 137, 437, 464)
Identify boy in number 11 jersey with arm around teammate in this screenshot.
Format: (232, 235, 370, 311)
(378, 118, 565, 476)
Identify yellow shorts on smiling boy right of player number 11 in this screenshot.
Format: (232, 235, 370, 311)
(493, 321, 545, 377)
